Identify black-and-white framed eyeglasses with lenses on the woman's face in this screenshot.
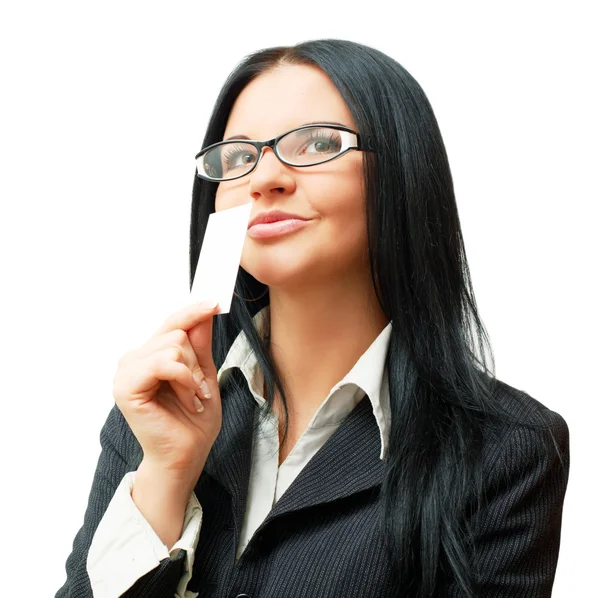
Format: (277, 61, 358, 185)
(196, 124, 368, 181)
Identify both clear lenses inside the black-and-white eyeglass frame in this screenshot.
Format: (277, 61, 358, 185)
(200, 127, 342, 179)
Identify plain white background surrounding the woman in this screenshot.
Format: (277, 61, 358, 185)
(0, 0, 600, 598)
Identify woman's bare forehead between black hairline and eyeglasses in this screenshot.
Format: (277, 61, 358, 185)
(223, 65, 356, 139)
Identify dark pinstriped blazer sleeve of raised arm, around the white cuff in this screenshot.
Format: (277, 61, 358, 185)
(55, 405, 186, 598)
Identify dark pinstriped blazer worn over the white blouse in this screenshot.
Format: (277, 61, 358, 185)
(56, 382, 569, 598)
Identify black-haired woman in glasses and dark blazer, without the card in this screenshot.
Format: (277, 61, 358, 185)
(57, 40, 569, 598)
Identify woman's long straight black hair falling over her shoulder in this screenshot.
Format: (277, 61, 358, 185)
(190, 39, 552, 596)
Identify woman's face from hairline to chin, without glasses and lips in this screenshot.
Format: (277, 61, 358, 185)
(215, 65, 368, 290)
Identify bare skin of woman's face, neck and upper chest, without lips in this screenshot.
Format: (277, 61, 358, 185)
(215, 65, 388, 463)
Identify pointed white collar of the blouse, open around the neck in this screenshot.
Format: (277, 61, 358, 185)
(217, 305, 392, 459)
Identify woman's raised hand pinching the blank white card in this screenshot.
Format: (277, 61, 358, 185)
(113, 304, 221, 479)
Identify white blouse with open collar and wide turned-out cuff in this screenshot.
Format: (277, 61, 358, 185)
(87, 306, 392, 598)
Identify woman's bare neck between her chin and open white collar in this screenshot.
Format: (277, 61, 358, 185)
(269, 275, 388, 423)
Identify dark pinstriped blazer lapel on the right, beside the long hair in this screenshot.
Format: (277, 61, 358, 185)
(261, 396, 384, 527)
